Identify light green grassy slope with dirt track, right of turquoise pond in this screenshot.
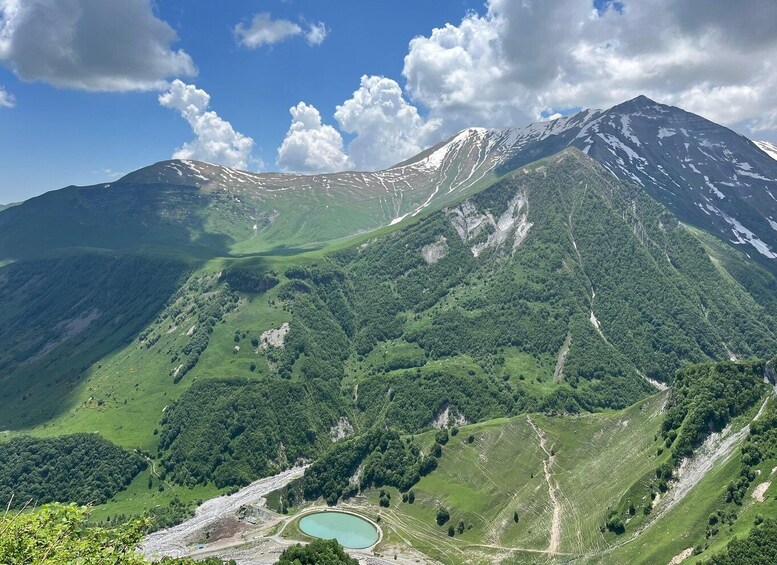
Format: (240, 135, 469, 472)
(354, 365, 777, 564)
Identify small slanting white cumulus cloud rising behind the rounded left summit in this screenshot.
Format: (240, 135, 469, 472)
(159, 80, 254, 169)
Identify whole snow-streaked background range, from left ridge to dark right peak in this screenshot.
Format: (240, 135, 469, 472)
(0, 96, 777, 270)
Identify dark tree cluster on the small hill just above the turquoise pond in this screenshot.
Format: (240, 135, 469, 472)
(303, 429, 437, 505)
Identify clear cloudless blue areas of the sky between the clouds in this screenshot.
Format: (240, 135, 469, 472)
(0, 0, 483, 202)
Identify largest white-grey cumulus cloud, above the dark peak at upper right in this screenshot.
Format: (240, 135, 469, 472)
(403, 0, 777, 138)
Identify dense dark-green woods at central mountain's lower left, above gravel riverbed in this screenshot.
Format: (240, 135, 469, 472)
(159, 378, 342, 487)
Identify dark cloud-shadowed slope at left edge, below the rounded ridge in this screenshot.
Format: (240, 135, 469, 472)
(0, 254, 189, 431)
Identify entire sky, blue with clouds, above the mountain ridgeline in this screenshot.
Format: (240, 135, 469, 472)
(0, 0, 777, 202)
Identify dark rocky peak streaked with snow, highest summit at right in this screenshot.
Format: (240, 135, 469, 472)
(488, 96, 777, 269)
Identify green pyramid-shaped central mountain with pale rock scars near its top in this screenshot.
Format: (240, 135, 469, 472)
(2, 150, 777, 468)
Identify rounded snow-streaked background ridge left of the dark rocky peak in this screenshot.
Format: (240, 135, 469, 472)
(0, 133, 510, 260)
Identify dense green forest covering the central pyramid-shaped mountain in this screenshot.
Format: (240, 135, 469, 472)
(150, 164, 777, 496)
